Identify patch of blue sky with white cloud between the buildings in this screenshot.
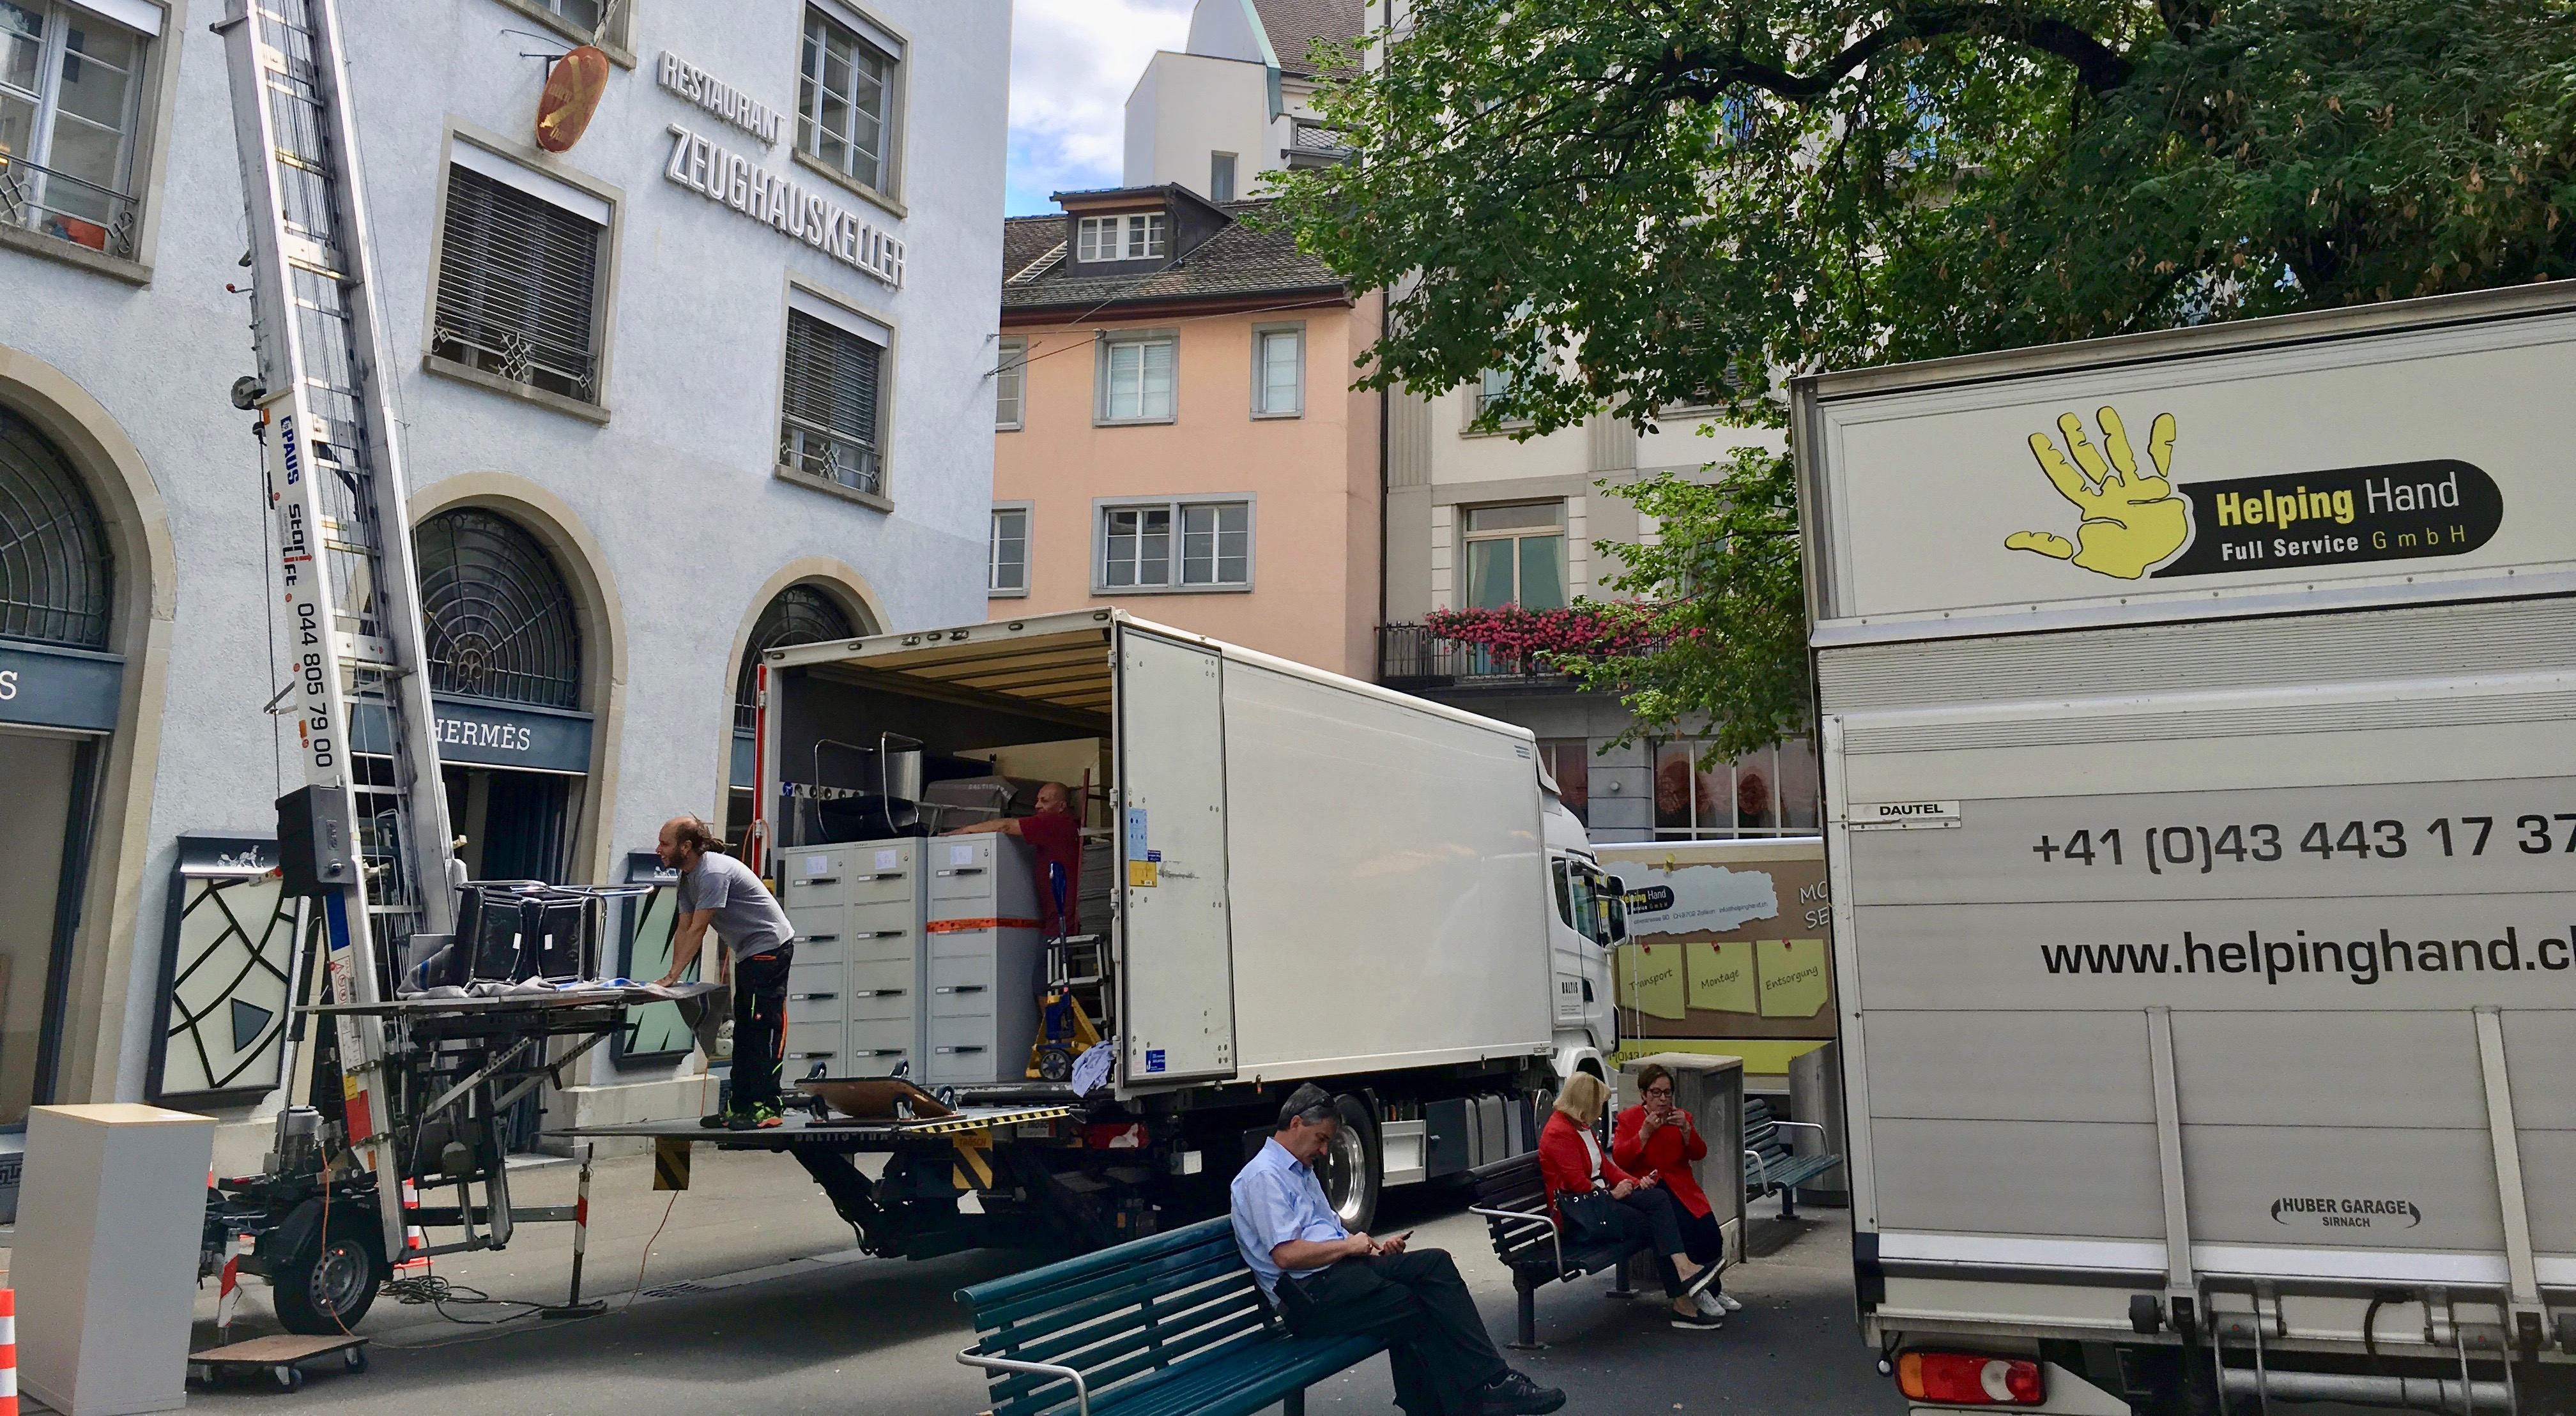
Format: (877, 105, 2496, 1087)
(1004, 0, 1193, 217)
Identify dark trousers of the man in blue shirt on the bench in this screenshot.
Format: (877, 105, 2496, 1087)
(1280, 1249, 1510, 1416)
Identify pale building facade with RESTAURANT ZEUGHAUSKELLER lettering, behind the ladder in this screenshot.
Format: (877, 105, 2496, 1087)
(0, 0, 1010, 1164)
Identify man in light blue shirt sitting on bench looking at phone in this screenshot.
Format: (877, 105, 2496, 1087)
(1234, 1084, 1566, 1416)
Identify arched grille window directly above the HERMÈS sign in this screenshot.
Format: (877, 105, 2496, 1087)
(412, 507, 582, 708)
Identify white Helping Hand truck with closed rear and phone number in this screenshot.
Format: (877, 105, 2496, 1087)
(1795, 283, 2576, 1413)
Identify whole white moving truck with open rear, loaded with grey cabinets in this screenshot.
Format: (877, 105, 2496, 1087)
(716, 610, 1620, 1254)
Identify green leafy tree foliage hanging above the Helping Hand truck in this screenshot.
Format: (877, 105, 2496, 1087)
(1273, 0, 2576, 747)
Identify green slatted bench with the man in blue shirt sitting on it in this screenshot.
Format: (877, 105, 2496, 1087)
(956, 1218, 1386, 1416)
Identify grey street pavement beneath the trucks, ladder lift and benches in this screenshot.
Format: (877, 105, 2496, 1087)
(25, 1148, 1904, 1416)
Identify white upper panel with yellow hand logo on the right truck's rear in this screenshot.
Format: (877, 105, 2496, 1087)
(1814, 302, 2576, 641)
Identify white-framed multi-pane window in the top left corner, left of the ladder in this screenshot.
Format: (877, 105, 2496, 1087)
(0, 0, 153, 265)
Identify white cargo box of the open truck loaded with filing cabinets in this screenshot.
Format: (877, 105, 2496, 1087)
(760, 610, 1553, 1097)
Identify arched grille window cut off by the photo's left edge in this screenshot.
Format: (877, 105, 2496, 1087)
(0, 409, 116, 649)
